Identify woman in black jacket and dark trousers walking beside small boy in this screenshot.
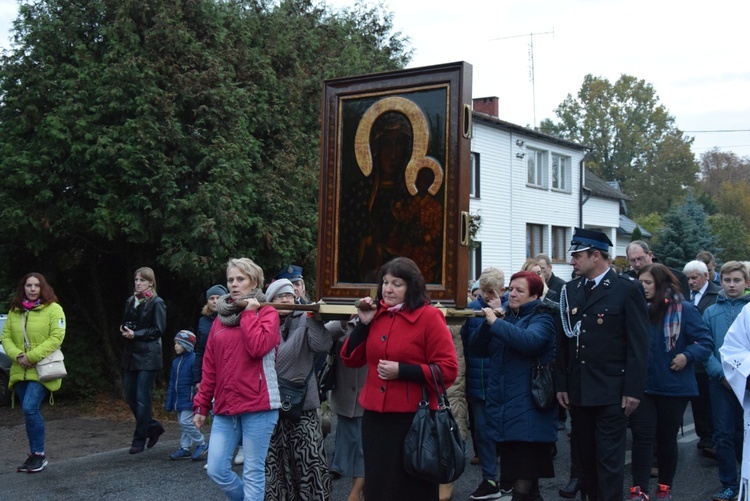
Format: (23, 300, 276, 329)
(120, 268, 167, 454)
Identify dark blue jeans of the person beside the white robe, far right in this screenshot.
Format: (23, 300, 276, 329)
(709, 381, 743, 490)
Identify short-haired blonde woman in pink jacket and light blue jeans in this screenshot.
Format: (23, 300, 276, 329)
(193, 258, 281, 500)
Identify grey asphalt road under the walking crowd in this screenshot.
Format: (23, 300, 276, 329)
(0, 407, 736, 501)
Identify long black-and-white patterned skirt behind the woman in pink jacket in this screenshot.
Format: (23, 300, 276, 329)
(265, 410, 332, 501)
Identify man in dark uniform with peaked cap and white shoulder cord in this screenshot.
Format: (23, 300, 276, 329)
(556, 228, 649, 501)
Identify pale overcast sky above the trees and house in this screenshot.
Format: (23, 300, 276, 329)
(0, 0, 750, 156)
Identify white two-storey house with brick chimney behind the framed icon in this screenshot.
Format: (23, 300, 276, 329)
(469, 97, 627, 280)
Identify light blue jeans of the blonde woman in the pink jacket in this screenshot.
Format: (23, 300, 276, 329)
(208, 410, 279, 501)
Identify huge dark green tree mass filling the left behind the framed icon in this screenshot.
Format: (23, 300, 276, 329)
(0, 0, 410, 396)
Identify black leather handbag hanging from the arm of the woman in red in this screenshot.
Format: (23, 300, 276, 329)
(403, 364, 466, 484)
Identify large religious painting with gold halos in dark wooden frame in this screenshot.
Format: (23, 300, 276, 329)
(316, 62, 471, 308)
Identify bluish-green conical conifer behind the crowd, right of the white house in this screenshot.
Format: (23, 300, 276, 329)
(653, 192, 716, 267)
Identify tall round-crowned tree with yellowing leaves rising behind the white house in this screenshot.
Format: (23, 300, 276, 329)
(540, 75, 698, 215)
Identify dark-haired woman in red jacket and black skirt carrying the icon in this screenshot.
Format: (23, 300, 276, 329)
(341, 257, 458, 501)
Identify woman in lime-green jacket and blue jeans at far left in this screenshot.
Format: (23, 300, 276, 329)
(2, 273, 65, 473)
